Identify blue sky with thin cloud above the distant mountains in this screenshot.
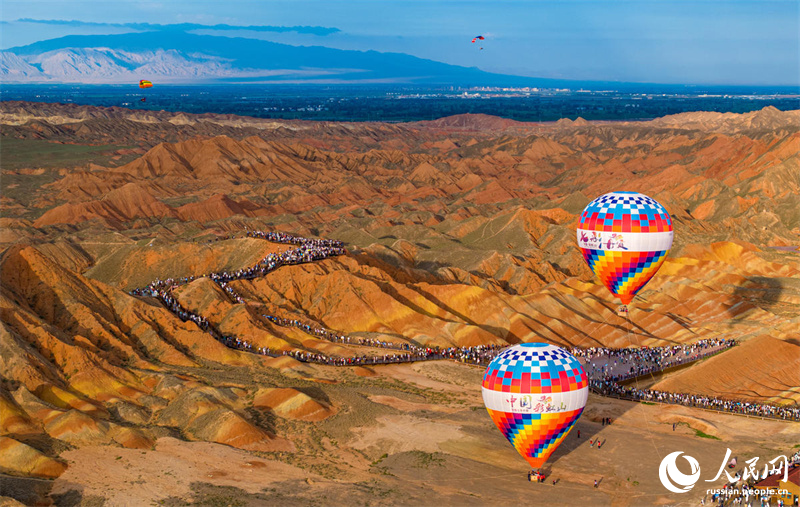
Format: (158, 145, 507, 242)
(0, 0, 800, 85)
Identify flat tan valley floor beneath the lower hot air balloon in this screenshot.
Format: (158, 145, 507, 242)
(3, 363, 800, 506)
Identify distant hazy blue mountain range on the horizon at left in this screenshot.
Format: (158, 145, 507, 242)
(0, 31, 544, 86)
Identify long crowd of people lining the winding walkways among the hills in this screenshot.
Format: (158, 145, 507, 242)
(130, 231, 800, 420)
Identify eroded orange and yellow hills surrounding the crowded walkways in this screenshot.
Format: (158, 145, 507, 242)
(0, 103, 800, 504)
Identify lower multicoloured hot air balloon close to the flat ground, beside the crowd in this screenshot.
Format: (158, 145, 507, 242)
(481, 343, 589, 468)
